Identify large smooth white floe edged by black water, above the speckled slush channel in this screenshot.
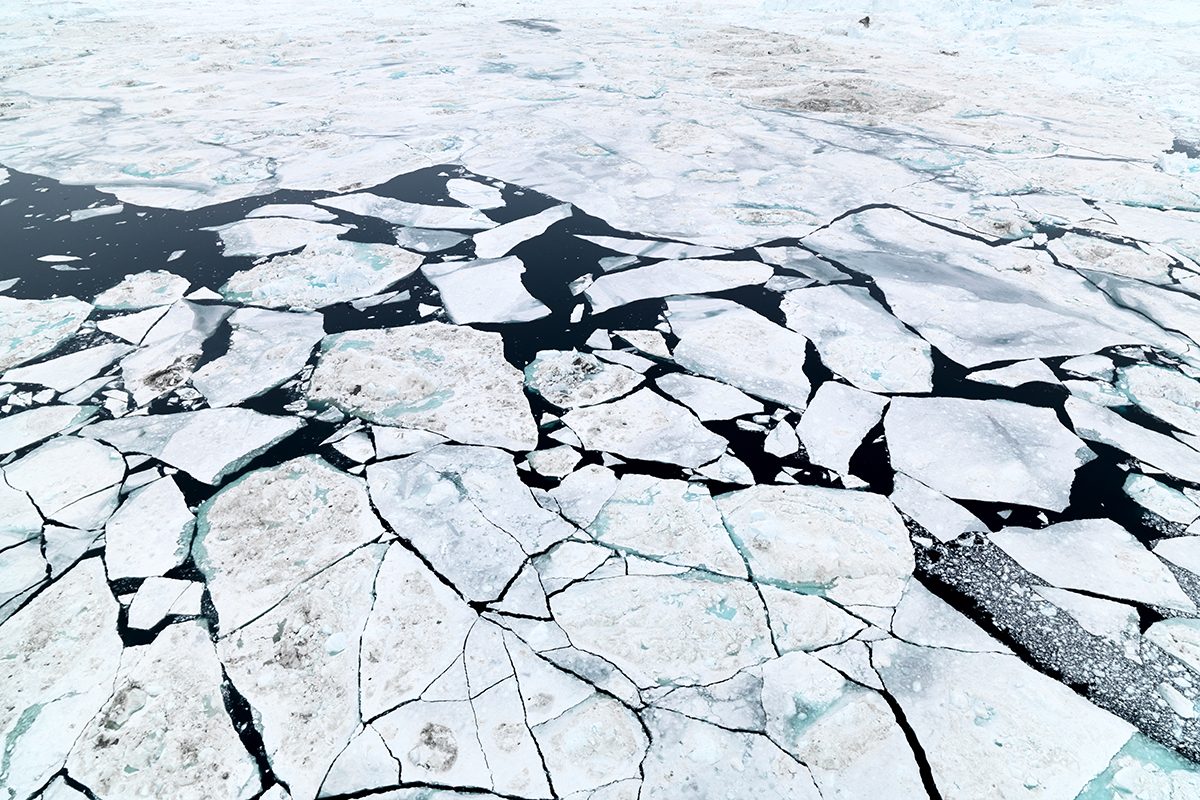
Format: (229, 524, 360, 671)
(883, 397, 1089, 511)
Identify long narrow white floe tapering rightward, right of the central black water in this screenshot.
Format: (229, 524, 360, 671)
(583, 259, 772, 314)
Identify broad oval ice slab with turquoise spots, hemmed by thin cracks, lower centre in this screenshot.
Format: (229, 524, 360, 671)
(550, 573, 774, 687)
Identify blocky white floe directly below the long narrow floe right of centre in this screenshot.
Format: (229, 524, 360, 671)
(667, 297, 809, 410)
